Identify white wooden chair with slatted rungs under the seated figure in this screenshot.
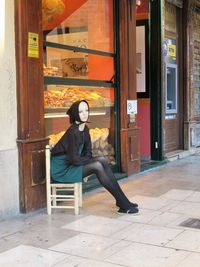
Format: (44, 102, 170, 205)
(45, 145, 82, 215)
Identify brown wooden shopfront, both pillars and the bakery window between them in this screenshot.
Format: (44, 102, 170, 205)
(15, 0, 140, 212)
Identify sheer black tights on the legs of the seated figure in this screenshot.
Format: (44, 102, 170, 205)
(83, 157, 130, 210)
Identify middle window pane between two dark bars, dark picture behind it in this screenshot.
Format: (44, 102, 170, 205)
(44, 47, 114, 81)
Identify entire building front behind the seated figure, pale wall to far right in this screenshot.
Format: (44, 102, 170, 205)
(0, 0, 200, 218)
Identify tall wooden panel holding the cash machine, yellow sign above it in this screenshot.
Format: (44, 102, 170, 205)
(164, 1, 183, 154)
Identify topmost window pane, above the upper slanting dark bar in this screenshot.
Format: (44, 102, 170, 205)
(43, 0, 113, 52)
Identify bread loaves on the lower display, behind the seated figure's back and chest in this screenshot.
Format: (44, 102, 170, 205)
(49, 128, 116, 165)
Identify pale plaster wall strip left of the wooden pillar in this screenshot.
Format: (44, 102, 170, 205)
(0, 1, 19, 218)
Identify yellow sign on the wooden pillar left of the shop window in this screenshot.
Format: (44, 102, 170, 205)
(28, 32, 39, 58)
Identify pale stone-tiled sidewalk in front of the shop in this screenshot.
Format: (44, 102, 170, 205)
(0, 154, 200, 267)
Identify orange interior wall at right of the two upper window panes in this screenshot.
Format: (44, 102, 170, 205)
(88, 0, 114, 80)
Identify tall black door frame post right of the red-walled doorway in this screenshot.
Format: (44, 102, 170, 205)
(149, 0, 164, 160)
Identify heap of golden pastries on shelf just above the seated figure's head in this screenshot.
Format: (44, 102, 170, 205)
(44, 87, 114, 108)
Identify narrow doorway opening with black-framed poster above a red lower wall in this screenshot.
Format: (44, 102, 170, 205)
(136, 19, 151, 170)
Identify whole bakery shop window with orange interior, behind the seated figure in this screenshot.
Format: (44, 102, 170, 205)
(43, 0, 117, 168)
